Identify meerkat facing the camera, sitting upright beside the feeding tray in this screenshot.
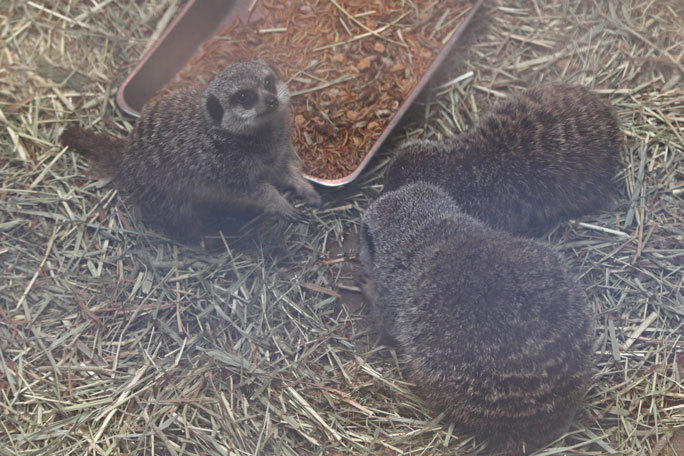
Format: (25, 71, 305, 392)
(61, 60, 321, 237)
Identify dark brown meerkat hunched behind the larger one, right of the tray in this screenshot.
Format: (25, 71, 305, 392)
(385, 84, 623, 233)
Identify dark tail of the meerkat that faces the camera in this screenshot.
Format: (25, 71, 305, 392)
(60, 126, 125, 177)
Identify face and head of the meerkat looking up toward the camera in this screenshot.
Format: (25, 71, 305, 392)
(202, 60, 290, 135)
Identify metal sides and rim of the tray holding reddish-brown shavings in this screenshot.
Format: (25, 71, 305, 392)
(116, 0, 484, 187)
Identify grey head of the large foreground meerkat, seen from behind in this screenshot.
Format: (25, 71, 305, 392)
(359, 182, 458, 274)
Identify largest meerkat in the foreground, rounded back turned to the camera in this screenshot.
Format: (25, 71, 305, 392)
(359, 182, 594, 455)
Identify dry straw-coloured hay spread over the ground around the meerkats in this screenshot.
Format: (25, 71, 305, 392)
(0, 0, 684, 456)
